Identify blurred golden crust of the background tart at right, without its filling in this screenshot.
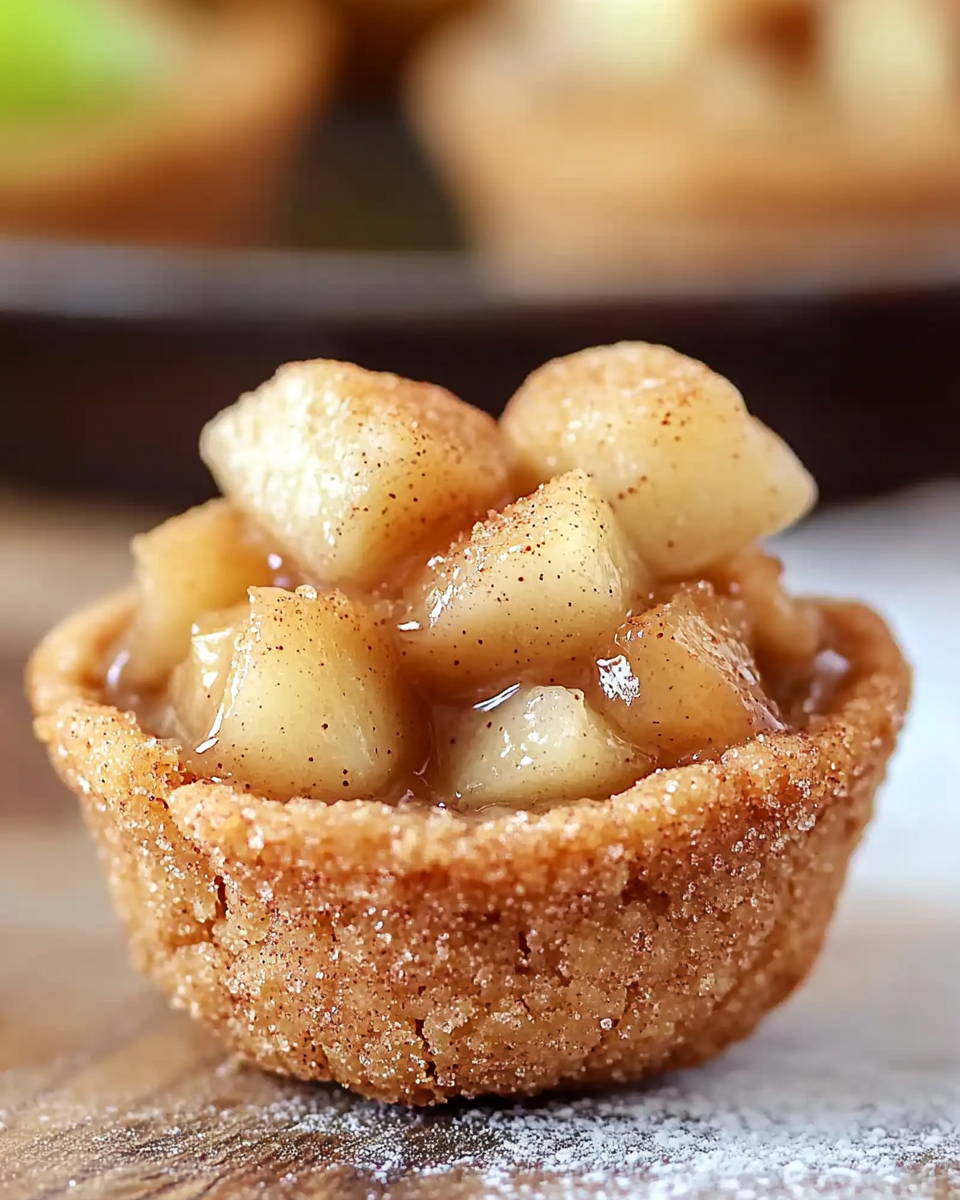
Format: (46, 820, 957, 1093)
(407, 11, 960, 287)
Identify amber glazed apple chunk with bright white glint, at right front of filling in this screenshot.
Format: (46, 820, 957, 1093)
(588, 583, 782, 767)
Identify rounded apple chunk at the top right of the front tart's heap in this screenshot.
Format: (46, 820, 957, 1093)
(502, 342, 816, 578)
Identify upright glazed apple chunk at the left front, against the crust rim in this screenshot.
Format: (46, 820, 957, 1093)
(171, 587, 424, 802)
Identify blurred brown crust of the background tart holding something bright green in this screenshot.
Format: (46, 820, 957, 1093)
(0, 0, 337, 246)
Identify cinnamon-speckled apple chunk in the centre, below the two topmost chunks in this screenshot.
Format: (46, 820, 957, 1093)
(400, 470, 649, 698)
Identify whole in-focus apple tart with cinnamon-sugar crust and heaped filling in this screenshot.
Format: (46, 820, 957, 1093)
(29, 343, 910, 1104)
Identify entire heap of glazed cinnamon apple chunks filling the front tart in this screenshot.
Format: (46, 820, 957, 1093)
(101, 344, 830, 809)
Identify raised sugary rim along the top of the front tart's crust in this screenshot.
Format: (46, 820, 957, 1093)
(28, 593, 910, 886)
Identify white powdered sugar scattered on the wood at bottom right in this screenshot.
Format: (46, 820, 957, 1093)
(277, 1048, 960, 1198)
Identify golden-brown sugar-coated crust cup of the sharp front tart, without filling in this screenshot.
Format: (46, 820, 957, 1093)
(28, 596, 910, 1104)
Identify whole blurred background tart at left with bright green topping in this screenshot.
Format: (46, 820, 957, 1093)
(0, 0, 334, 245)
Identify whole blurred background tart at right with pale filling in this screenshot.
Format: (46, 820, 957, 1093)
(410, 0, 960, 286)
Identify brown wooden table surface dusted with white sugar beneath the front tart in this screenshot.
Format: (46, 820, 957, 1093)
(0, 494, 960, 1200)
